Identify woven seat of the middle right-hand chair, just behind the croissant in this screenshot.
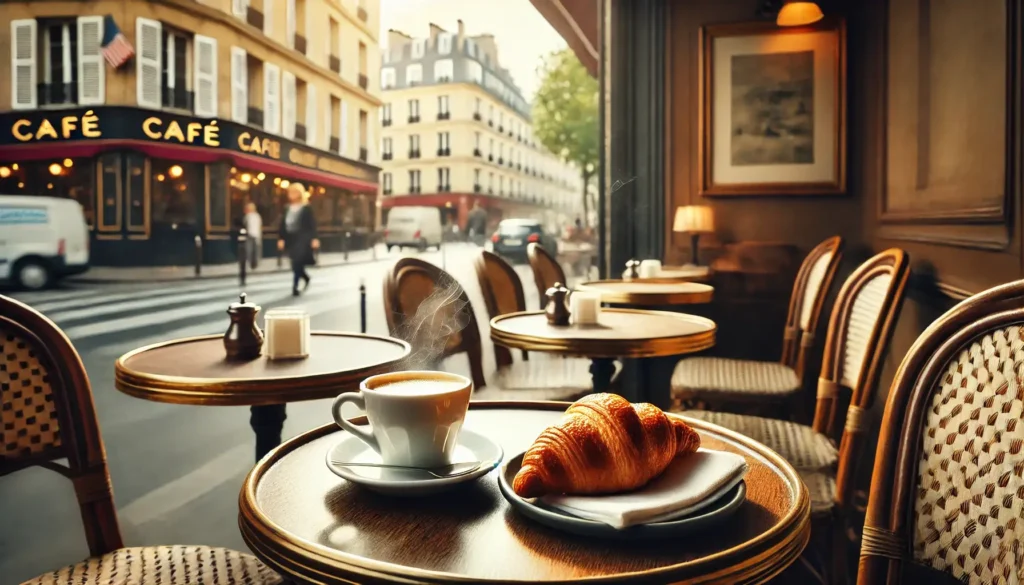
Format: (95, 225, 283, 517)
(683, 411, 839, 471)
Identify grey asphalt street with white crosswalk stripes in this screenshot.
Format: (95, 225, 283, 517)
(0, 244, 569, 585)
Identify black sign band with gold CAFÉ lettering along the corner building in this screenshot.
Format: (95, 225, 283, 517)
(0, 107, 377, 181)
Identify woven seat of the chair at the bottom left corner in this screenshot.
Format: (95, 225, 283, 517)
(22, 546, 284, 585)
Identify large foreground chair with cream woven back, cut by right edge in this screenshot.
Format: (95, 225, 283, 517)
(857, 281, 1024, 585)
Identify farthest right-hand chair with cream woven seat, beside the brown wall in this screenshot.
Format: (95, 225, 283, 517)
(672, 236, 843, 418)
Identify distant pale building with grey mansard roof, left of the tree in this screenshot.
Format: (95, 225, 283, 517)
(380, 22, 583, 233)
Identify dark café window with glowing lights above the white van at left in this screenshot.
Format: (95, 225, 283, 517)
(0, 158, 96, 226)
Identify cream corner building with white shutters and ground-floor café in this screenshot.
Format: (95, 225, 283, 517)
(0, 0, 380, 265)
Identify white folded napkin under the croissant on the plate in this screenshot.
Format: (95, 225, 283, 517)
(540, 449, 746, 529)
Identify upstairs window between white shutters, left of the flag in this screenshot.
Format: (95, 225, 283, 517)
(38, 18, 79, 106)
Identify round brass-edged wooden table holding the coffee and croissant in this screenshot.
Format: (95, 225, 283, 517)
(239, 403, 810, 585)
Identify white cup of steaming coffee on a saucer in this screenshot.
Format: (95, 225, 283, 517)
(331, 371, 473, 467)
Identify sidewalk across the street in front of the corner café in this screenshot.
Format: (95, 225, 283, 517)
(69, 246, 388, 284)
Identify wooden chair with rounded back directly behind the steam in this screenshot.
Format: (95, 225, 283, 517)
(384, 258, 592, 401)
